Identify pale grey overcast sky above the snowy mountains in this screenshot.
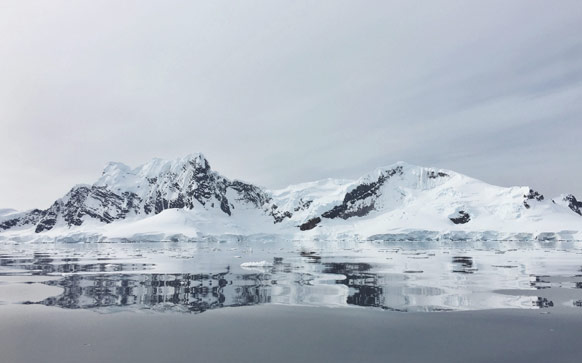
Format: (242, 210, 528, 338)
(0, 0, 582, 209)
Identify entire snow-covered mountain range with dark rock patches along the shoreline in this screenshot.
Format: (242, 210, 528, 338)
(0, 154, 582, 241)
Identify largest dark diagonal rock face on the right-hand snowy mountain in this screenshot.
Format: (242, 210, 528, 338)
(321, 166, 402, 219)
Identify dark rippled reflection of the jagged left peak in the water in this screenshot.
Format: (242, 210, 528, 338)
(40, 270, 271, 313)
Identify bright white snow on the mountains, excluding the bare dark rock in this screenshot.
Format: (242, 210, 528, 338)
(0, 154, 582, 241)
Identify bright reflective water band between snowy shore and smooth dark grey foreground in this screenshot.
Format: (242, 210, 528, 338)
(0, 241, 582, 313)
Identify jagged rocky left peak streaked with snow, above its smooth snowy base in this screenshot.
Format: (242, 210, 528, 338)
(0, 154, 292, 233)
